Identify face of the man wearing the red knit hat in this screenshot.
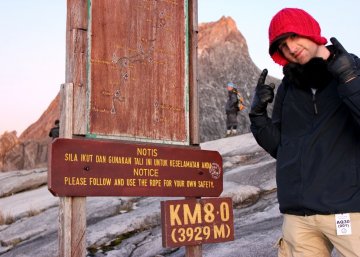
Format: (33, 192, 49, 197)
(278, 34, 319, 64)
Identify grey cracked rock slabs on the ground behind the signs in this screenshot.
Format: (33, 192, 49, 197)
(0, 134, 335, 257)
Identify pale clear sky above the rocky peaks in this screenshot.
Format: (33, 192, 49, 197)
(0, 0, 360, 136)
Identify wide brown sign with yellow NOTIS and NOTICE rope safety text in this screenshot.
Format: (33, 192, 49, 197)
(48, 138, 223, 197)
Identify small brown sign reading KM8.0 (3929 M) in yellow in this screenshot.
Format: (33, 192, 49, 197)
(161, 198, 234, 247)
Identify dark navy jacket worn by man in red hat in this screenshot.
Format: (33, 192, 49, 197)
(250, 56, 360, 215)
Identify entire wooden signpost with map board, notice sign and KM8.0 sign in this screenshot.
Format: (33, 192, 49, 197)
(52, 0, 233, 257)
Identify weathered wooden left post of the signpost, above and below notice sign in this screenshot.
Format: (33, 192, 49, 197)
(59, 0, 88, 254)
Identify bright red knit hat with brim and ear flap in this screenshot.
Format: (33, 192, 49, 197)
(269, 8, 327, 66)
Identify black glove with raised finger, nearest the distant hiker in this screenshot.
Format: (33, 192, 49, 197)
(249, 69, 275, 116)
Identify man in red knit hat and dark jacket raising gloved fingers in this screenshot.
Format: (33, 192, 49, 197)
(249, 8, 360, 257)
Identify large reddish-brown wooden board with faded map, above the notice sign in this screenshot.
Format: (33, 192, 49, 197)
(87, 0, 189, 145)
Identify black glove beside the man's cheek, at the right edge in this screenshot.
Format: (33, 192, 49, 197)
(328, 37, 359, 84)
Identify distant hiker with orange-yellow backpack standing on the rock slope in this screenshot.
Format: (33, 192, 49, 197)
(225, 82, 243, 137)
